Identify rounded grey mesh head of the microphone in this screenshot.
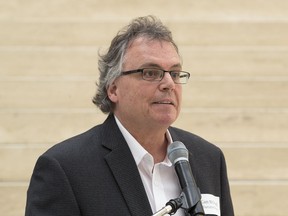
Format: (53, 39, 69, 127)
(167, 141, 188, 165)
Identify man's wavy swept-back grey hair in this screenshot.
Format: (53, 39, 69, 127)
(93, 15, 178, 113)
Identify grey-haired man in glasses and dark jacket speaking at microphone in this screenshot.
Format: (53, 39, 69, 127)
(26, 16, 234, 216)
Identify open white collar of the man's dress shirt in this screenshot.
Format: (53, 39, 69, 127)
(114, 115, 173, 166)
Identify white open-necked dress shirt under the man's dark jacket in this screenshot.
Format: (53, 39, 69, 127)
(115, 116, 184, 216)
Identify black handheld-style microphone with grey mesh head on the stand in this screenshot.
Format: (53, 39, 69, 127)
(167, 141, 205, 216)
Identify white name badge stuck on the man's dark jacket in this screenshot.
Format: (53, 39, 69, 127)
(201, 194, 221, 216)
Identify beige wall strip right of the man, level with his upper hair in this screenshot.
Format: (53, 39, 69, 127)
(170, 21, 288, 46)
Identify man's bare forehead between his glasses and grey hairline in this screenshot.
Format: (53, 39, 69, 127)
(123, 37, 181, 69)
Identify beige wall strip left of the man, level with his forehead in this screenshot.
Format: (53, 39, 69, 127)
(0, 47, 100, 77)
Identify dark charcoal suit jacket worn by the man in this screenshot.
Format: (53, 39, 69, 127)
(25, 115, 233, 216)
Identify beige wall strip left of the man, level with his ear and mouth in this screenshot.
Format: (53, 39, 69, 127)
(0, 80, 96, 109)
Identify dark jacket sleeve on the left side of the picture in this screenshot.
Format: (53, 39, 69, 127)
(25, 156, 81, 216)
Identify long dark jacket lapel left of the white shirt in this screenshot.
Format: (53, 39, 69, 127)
(102, 115, 152, 216)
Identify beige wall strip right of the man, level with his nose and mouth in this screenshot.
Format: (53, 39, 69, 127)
(182, 80, 288, 108)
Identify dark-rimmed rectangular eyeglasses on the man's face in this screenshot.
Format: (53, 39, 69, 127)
(121, 68, 190, 84)
